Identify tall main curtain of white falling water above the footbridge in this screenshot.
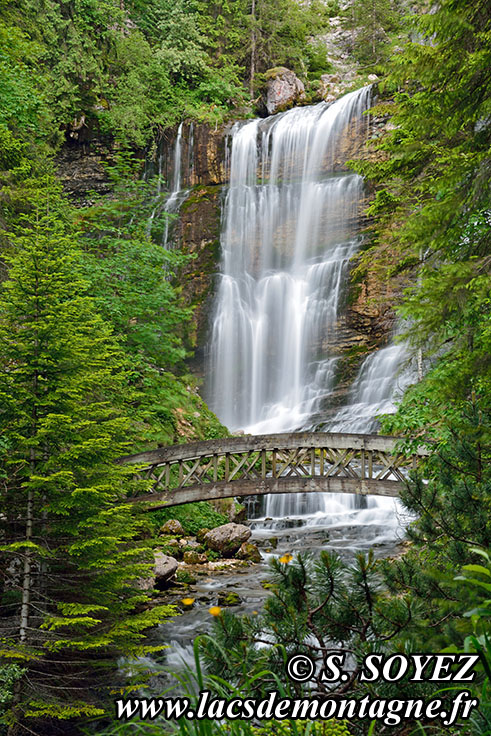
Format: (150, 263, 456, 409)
(207, 87, 370, 433)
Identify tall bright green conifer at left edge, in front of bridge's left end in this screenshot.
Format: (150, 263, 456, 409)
(0, 208, 174, 736)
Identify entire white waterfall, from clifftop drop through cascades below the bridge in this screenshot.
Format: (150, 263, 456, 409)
(153, 88, 416, 670)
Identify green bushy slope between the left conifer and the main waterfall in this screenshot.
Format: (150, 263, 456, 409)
(78, 152, 226, 447)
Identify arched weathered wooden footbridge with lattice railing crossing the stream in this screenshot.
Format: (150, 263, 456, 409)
(120, 432, 429, 509)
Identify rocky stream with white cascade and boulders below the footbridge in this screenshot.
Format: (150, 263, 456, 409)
(142, 494, 410, 691)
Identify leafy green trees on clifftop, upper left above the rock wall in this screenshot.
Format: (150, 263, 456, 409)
(0, 0, 338, 147)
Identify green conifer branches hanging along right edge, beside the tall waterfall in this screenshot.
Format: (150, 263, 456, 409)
(355, 0, 491, 436)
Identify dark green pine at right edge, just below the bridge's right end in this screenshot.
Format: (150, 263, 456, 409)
(384, 403, 491, 647)
